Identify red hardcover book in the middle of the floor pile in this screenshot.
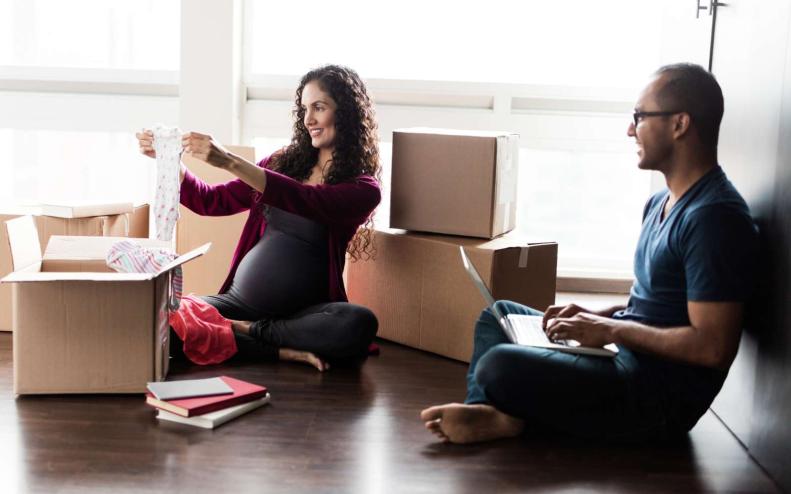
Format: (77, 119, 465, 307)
(146, 376, 267, 417)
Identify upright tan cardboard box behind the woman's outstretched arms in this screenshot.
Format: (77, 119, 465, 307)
(176, 146, 255, 295)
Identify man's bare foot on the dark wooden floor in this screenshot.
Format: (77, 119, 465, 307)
(420, 403, 525, 444)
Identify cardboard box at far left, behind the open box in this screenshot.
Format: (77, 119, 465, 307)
(0, 204, 149, 331)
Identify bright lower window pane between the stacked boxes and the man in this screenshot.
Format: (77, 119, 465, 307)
(517, 148, 651, 277)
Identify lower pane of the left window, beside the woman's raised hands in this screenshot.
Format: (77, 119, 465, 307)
(0, 92, 178, 205)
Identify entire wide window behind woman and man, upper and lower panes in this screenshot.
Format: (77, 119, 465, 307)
(243, 0, 669, 278)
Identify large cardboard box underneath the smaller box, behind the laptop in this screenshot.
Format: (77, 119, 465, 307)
(348, 230, 558, 362)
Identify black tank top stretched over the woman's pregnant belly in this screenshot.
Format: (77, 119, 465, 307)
(228, 206, 329, 318)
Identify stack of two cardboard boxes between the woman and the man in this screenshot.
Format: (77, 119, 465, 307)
(348, 128, 557, 361)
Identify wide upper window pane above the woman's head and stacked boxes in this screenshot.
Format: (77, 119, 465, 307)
(245, 0, 662, 87)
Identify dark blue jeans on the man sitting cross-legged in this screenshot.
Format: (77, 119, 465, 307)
(465, 301, 723, 441)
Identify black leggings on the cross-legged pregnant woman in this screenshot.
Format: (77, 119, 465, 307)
(170, 295, 378, 362)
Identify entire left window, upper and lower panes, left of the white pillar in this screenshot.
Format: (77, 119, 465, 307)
(0, 0, 181, 209)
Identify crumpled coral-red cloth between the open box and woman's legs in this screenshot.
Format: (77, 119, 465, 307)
(168, 295, 237, 365)
